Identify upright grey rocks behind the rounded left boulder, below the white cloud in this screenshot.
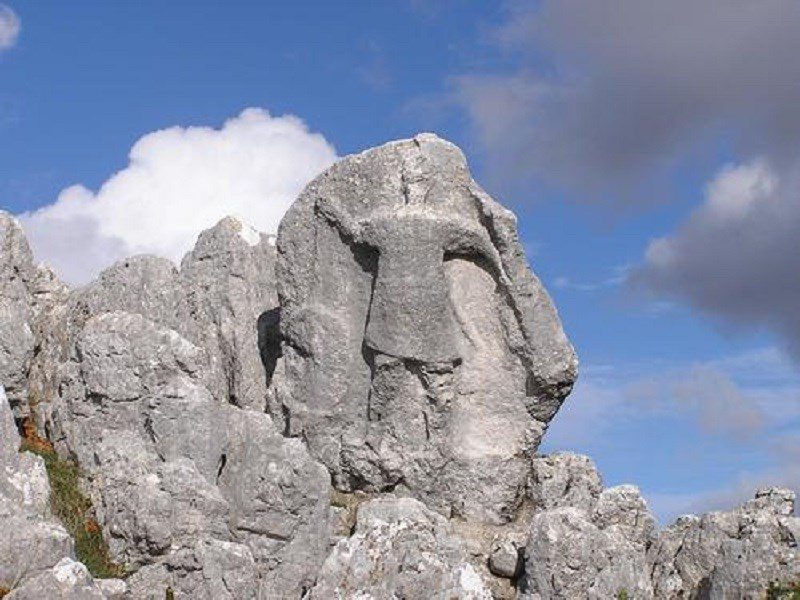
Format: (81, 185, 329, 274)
(31, 217, 280, 441)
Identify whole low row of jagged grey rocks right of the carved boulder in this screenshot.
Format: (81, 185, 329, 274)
(520, 453, 800, 600)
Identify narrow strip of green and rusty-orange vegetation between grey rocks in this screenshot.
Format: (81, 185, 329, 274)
(18, 422, 127, 580)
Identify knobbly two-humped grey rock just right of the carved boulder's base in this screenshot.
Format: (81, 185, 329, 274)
(520, 452, 655, 600)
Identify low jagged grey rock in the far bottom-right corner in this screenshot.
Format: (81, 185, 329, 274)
(649, 488, 800, 600)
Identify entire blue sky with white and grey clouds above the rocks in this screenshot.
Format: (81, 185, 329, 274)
(0, 0, 800, 519)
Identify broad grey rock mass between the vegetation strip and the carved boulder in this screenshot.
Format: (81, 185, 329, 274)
(12, 218, 330, 598)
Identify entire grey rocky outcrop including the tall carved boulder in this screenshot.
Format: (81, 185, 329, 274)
(0, 134, 800, 600)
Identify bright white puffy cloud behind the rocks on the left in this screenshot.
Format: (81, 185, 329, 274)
(20, 108, 336, 283)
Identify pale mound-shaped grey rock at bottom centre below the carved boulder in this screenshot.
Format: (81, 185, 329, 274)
(310, 498, 492, 600)
